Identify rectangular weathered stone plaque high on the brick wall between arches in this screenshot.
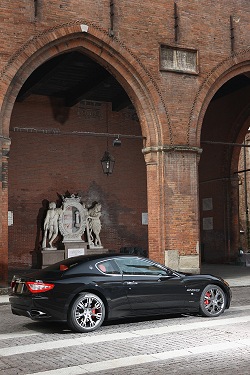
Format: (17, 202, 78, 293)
(160, 45, 198, 74)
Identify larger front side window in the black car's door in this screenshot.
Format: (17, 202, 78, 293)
(115, 257, 168, 276)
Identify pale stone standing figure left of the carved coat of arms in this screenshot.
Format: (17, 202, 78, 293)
(42, 202, 62, 249)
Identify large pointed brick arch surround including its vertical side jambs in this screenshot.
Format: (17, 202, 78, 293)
(0, 20, 174, 282)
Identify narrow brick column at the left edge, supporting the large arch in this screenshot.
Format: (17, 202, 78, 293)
(0, 136, 11, 286)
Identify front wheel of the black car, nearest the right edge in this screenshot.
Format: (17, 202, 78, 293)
(200, 284, 226, 317)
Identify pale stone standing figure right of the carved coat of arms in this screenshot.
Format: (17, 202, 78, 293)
(88, 203, 102, 247)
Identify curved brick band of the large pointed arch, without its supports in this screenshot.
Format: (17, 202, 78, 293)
(0, 20, 173, 146)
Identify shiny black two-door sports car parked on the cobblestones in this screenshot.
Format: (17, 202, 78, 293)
(10, 254, 231, 332)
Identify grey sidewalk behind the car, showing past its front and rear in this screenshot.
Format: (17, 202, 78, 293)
(0, 264, 250, 305)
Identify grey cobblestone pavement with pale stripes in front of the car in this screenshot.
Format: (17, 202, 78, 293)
(0, 287, 250, 375)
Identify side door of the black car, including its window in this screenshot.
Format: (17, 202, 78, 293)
(116, 257, 186, 314)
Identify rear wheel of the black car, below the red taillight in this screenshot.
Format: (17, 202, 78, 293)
(68, 293, 105, 332)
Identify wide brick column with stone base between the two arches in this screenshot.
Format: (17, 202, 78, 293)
(143, 146, 201, 273)
